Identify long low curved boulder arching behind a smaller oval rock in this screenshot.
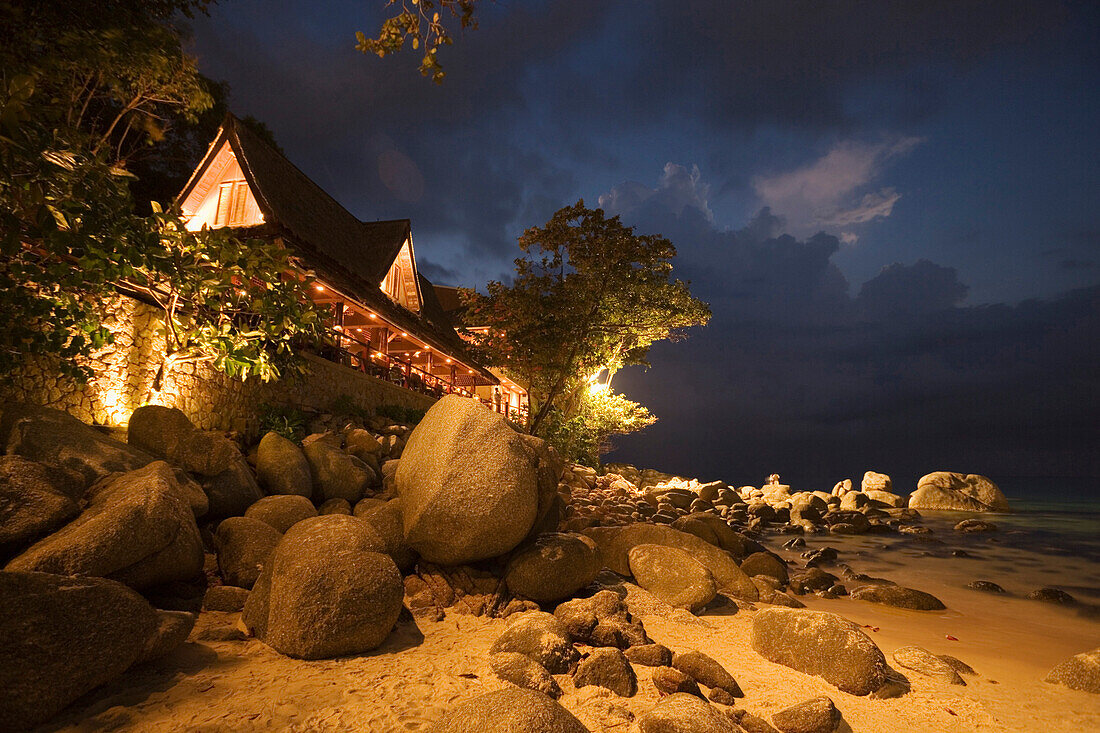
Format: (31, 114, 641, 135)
(584, 523, 760, 601)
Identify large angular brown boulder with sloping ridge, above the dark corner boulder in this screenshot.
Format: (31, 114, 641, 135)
(4, 461, 202, 590)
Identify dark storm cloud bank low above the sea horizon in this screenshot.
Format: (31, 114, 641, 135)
(612, 168, 1100, 489)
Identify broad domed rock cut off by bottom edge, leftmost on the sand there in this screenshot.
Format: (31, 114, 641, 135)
(432, 687, 589, 733)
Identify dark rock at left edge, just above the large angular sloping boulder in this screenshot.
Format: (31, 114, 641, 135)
(0, 456, 83, 559)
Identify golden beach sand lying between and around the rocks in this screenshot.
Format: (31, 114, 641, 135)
(40, 508, 1100, 733)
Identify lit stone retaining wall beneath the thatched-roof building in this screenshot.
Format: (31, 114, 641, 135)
(0, 296, 435, 434)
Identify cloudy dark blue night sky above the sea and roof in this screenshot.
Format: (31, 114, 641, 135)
(184, 0, 1100, 490)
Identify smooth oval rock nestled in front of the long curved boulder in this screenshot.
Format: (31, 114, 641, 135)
(629, 545, 717, 613)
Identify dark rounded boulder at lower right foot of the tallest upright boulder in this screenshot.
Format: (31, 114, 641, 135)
(504, 533, 603, 603)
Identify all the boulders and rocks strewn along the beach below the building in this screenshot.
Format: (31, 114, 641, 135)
(0, 396, 1096, 732)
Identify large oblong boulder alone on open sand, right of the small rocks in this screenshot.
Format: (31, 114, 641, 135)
(752, 608, 887, 696)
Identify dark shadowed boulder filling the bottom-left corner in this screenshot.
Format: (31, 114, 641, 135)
(0, 572, 158, 731)
